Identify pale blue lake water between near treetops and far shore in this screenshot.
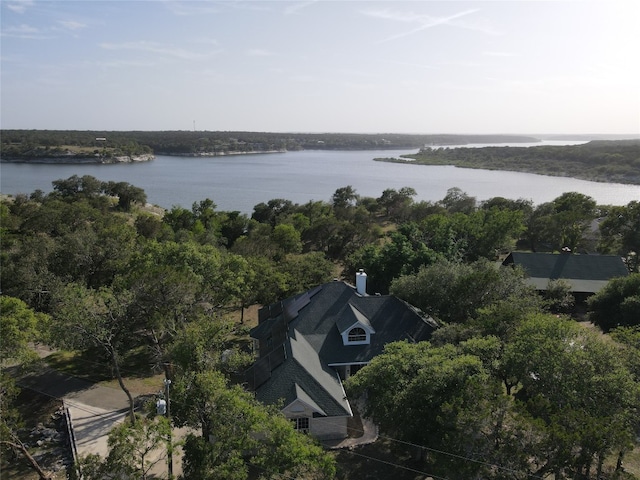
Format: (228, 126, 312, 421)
(0, 145, 640, 214)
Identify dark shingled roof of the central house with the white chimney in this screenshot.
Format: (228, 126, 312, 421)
(248, 281, 437, 416)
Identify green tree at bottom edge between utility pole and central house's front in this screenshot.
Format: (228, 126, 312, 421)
(177, 370, 335, 480)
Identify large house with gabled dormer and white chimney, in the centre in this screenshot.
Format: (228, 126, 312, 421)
(246, 271, 437, 440)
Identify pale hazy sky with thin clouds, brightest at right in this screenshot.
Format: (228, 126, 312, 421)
(0, 0, 640, 135)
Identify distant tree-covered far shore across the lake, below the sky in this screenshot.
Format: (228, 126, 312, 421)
(0, 130, 640, 185)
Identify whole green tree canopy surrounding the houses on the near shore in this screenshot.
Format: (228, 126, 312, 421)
(6, 172, 640, 479)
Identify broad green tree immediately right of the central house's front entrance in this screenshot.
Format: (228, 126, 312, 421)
(346, 342, 524, 478)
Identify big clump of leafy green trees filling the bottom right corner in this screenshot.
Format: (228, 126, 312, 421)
(346, 314, 640, 479)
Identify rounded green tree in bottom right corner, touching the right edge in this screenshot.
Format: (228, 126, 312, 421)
(504, 315, 640, 478)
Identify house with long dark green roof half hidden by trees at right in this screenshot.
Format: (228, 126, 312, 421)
(502, 252, 629, 300)
